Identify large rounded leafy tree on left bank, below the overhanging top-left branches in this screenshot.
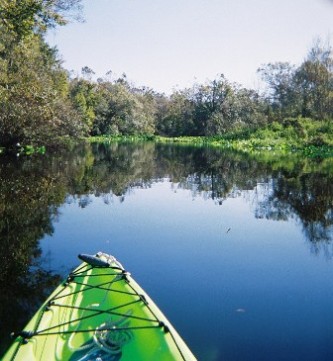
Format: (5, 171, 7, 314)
(0, 35, 81, 146)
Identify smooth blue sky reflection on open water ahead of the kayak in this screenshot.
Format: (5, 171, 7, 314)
(42, 179, 333, 361)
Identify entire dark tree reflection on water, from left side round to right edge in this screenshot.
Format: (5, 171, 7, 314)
(0, 143, 333, 353)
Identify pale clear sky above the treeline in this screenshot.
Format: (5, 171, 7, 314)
(47, 0, 333, 94)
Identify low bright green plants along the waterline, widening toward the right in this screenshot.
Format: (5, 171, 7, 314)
(89, 118, 333, 158)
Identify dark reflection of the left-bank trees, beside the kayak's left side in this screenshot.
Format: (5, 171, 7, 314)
(0, 145, 89, 354)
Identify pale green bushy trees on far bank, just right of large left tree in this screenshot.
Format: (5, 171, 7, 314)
(71, 73, 156, 135)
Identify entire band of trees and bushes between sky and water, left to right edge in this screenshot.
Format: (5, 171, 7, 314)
(0, 0, 333, 148)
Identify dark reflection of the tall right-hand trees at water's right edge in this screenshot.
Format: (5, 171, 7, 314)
(255, 169, 333, 258)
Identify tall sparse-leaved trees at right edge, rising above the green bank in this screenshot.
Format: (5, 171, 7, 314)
(258, 40, 333, 120)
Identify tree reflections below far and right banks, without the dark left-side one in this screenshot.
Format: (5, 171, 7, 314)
(83, 143, 333, 253)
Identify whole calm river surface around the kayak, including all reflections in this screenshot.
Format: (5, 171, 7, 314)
(0, 143, 333, 361)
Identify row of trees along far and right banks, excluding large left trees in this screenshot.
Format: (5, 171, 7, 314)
(84, 38, 333, 142)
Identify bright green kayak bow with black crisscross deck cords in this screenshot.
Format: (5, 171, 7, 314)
(3, 252, 196, 361)
